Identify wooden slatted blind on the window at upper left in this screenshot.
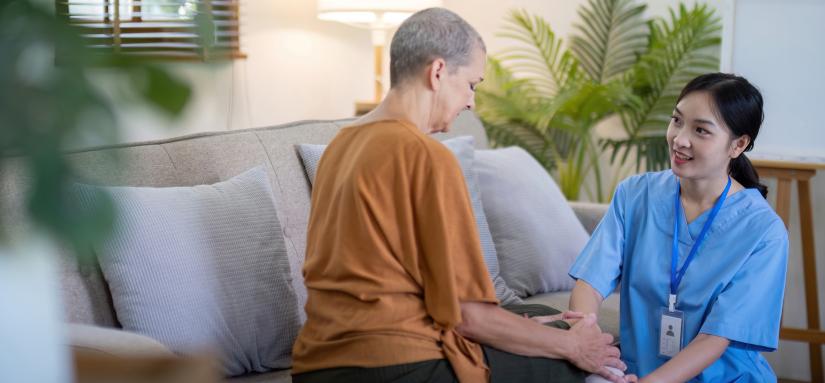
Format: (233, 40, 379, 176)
(56, 0, 244, 60)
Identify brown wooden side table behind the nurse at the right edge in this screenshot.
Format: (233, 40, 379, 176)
(752, 159, 825, 383)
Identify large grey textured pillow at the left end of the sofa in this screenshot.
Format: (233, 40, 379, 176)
(77, 166, 300, 375)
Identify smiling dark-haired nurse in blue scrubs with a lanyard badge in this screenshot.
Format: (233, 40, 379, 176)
(570, 73, 788, 382)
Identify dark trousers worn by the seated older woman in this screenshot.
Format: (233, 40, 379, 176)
(292, 304, 586, 383)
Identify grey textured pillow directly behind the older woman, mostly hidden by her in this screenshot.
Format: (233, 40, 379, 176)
(298, 136, 522, 305)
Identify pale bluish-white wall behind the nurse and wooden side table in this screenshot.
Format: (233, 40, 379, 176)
(723, 0, 825, 380)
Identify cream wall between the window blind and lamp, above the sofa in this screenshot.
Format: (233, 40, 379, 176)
(107, 0, 373, 142)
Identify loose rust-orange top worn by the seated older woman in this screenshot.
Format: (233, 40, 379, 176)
(292, 121, 497, 382)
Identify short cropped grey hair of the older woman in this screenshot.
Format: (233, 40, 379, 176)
(390, 8, 487, 88)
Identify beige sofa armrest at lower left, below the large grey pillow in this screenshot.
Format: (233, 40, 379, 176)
(66, 323, 175, 357)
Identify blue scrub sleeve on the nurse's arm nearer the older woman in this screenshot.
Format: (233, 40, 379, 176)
(569, 183, 625, 298)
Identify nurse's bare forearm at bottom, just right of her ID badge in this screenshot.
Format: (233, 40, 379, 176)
(641, 334, 730, 383)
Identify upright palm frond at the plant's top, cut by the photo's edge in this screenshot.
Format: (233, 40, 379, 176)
(570, 0, 648, 84)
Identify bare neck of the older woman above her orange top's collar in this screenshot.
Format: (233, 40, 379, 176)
(356, 86, 432, 134)
